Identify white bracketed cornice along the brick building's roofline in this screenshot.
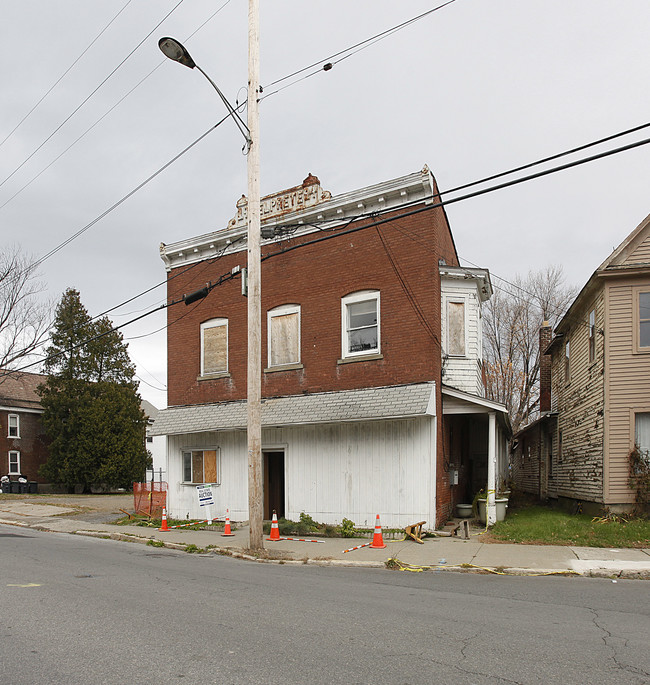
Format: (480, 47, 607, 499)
(160, 165, 434, 271)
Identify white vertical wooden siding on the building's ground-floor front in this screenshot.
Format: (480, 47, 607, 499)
(168, 417, 435, 528)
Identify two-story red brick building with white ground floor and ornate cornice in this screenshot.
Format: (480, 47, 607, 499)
(152, 167, 507, 528)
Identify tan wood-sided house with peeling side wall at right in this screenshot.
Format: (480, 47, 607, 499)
(512, 216, 650, 512)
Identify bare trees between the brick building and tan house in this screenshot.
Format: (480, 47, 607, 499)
(483, 266, 577, 432)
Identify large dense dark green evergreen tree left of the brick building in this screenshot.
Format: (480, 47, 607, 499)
(39, 288, 149, 492)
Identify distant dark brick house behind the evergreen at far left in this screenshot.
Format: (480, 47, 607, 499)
(0, 371, 49, 483)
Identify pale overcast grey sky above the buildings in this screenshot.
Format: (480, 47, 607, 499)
(0, 0, 650, 408)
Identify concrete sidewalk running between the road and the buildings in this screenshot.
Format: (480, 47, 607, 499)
(0, 499, 650, 579)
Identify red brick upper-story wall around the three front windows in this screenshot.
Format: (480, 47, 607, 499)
(168, 203, 457, 405)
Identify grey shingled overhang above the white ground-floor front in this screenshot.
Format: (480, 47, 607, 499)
(150, 382, 436, 436)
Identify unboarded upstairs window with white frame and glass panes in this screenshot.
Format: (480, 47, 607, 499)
(341, 290, 380, 359)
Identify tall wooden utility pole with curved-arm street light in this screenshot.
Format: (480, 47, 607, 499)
(158, 16, 264, 549)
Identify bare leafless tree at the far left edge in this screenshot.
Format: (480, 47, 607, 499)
(0, 247, 51, 383)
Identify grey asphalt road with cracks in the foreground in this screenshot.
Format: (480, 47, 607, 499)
(0, 526, 650, 685)
